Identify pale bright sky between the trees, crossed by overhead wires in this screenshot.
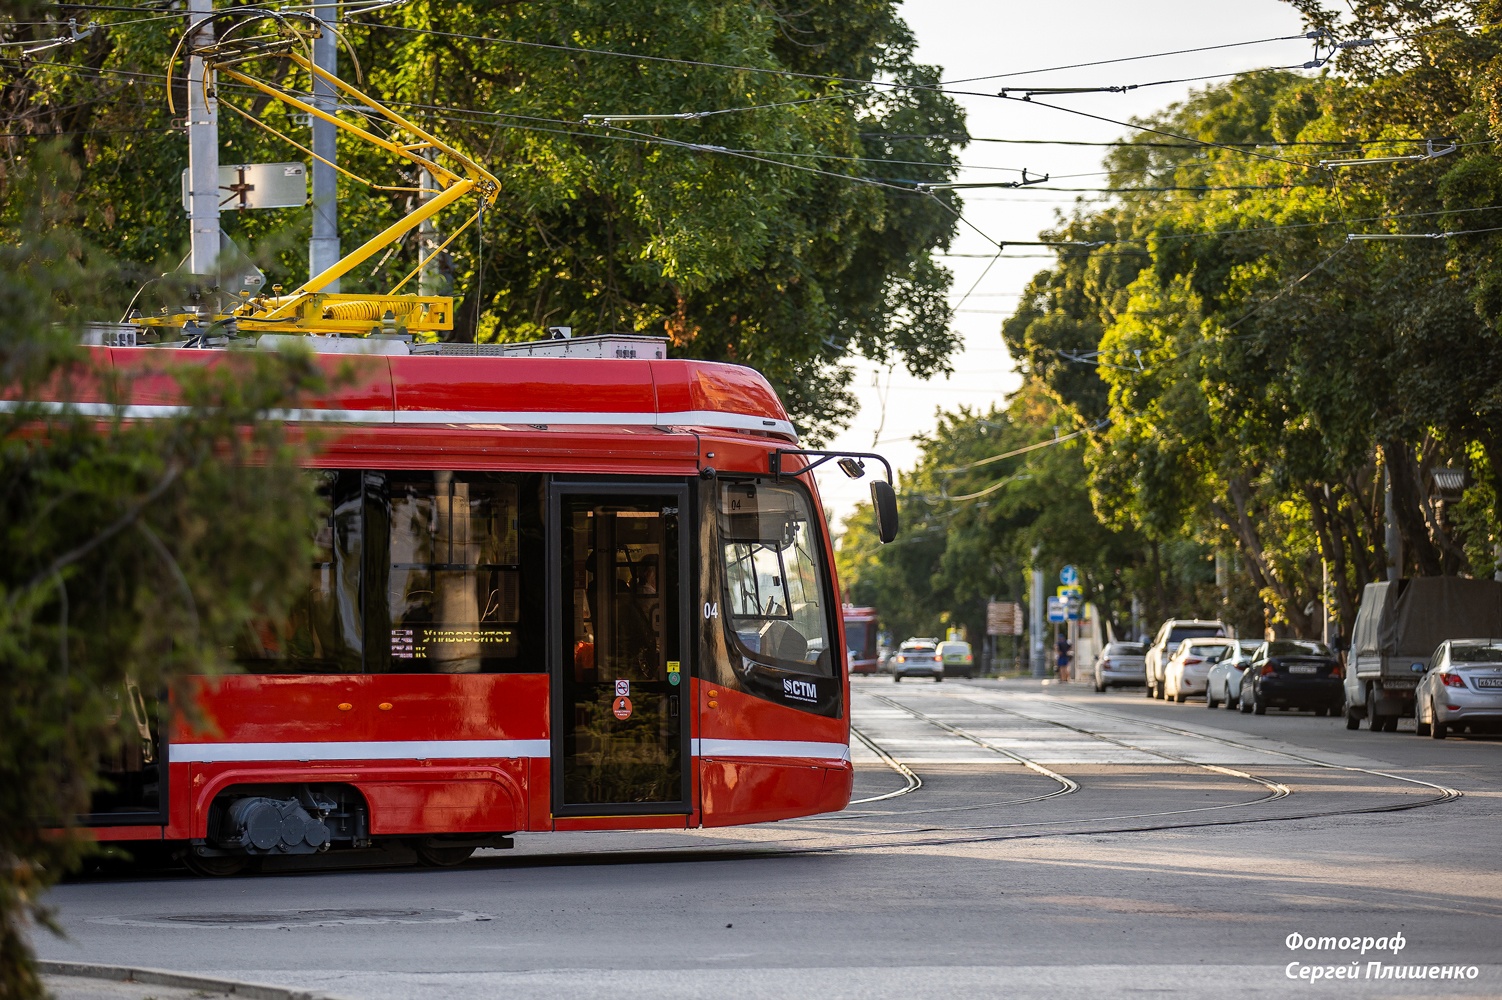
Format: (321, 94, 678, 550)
(819, 0, 1313, 524)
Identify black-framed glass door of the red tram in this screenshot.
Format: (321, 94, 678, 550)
(548, 483, 692, 817)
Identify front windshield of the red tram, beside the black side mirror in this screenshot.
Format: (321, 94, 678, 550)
(719, 482, 834, 677)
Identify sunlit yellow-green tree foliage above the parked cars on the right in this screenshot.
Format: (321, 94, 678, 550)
(852, 0, 1502, 645)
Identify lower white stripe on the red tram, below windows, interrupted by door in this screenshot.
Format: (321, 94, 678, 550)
(168, 739, 850, 764)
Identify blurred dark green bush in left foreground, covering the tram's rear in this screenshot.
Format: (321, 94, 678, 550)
(0, 149, 318, 998)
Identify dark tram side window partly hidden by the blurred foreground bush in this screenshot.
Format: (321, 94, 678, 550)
(236, 470, 363, 674)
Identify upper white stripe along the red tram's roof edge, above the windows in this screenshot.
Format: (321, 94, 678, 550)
(0, 399, 798, 440)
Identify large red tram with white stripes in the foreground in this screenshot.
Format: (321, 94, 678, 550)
(49, 330, 895, 874)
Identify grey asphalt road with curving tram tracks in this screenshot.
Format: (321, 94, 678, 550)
(36, 677, 1502, 1000)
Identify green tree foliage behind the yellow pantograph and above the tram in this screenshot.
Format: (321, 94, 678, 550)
(0, 0, 964, 438)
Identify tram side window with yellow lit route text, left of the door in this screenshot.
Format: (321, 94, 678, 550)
(381, 471, 521, 674)
